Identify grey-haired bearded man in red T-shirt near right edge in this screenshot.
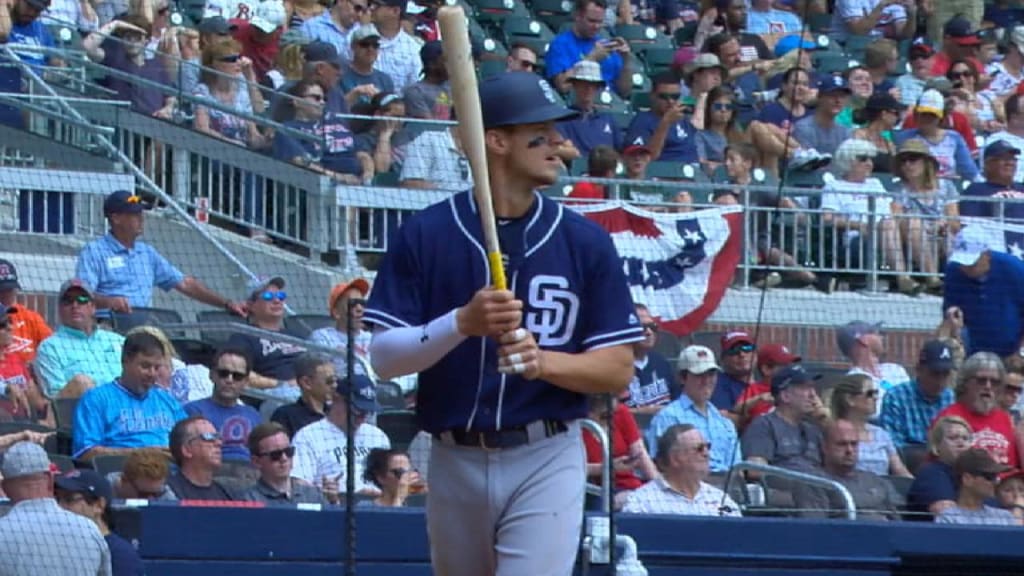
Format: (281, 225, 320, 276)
(938, 352, 1020, 467)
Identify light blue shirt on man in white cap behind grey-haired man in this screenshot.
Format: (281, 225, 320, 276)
(647, 394, 742, 472)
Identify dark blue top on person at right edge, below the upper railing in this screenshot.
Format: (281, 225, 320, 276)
(942, 251, 1024, 358)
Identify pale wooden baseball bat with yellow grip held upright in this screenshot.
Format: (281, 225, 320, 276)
(437, 5, 508, 290)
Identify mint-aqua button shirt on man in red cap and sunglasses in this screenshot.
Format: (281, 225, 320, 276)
(35, 326, 125, 398)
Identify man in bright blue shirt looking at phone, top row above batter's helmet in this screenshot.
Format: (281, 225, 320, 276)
(544, 0, 633, 97)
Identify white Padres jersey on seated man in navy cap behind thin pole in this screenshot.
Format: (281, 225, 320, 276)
(292, 418, 391, 492)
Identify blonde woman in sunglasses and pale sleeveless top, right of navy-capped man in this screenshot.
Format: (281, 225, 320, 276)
(831, 374, 912, 478)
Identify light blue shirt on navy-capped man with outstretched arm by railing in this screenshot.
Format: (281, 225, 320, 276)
(75, 234, 185, 316)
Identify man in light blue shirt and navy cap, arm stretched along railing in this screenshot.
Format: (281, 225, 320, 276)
(75, 190, 245, 317)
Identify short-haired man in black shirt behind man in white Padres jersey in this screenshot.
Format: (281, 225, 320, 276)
(270, 353, 333, 438)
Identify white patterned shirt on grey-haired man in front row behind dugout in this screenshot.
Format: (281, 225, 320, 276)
(623, 478, 742, 518)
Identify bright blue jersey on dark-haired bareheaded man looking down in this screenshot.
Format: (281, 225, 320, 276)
(72, 380, 186, 458)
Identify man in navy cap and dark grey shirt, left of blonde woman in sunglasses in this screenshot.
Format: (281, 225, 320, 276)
(742, 364, 827, 478)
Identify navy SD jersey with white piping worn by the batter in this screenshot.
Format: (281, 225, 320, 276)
(364, 193, 643, 433)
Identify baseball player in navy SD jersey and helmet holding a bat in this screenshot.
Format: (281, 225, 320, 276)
(364, 72, 643, 576)
